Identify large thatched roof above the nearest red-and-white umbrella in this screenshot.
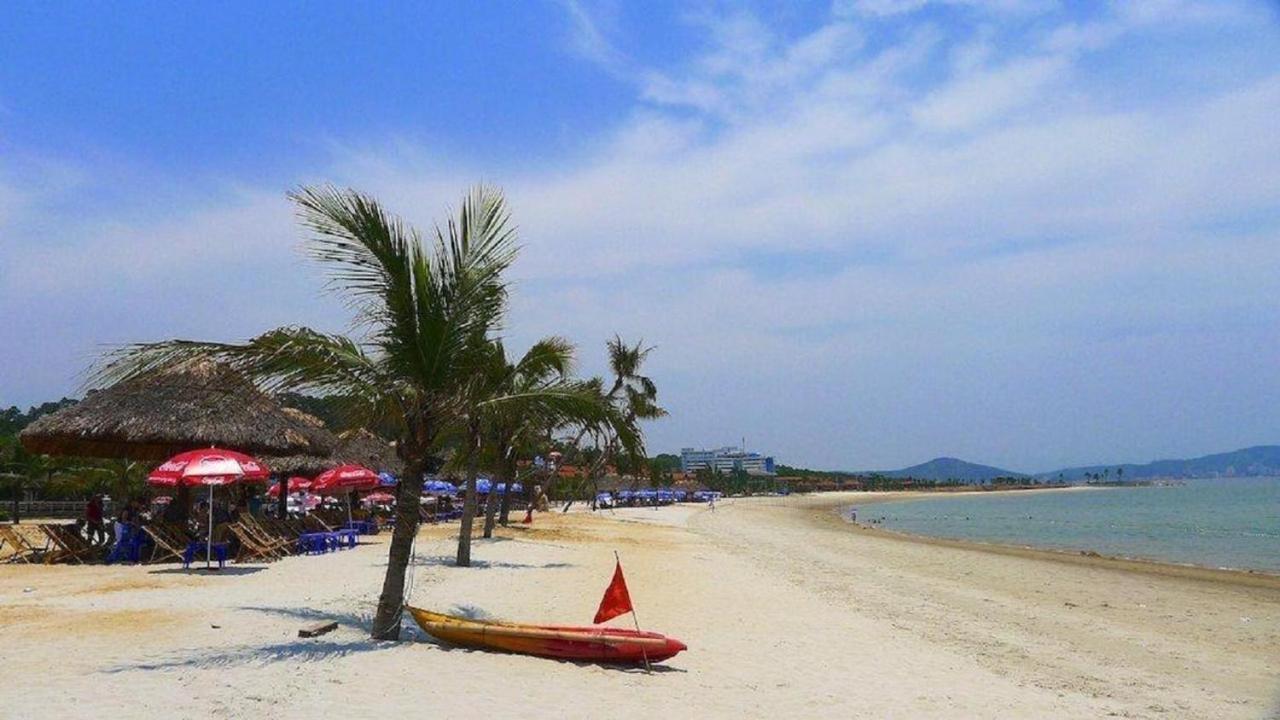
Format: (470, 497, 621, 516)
(19, 360, 337, 460)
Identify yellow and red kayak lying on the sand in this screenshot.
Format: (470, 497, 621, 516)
(404, 606, 687, 665)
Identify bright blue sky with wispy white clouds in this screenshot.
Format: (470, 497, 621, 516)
(0, 0, 1280, 470)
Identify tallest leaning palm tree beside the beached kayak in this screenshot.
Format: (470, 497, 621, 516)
(92, 187, 516, 639)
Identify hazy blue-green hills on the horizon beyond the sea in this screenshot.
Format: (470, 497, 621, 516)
(778, 445, 1280, 484)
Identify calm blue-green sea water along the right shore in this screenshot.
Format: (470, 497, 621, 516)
(855, 478, 1280, 571)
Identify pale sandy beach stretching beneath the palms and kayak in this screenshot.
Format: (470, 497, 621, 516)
(0, 493, 1280, 719)
